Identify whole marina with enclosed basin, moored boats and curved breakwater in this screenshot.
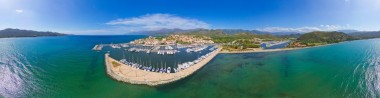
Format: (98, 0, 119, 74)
(100, 35, 222, 86)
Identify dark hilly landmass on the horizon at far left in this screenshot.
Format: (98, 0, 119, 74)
(0, 28, 66, 38)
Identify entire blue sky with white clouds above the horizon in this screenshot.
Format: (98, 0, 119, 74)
(0, 0, 380, 35)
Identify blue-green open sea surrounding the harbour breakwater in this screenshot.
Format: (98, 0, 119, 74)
(0, 36, 380, 98)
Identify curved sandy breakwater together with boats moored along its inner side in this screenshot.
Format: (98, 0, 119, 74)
(105, 48, 221, 86)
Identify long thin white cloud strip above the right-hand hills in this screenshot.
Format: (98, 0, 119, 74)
(258, 24, 350, 33)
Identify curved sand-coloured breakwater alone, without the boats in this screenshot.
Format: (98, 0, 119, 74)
(105, 48, 221, 86)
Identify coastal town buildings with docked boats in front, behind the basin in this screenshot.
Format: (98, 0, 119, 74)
(93, 35, 215, 55)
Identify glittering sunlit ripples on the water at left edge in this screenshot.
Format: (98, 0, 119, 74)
(0, 43, 43, 98)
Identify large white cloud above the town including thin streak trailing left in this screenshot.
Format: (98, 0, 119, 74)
(63, 14, 210, 35)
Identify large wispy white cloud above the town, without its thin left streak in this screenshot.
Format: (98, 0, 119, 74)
(106, 14, 210, 31)
